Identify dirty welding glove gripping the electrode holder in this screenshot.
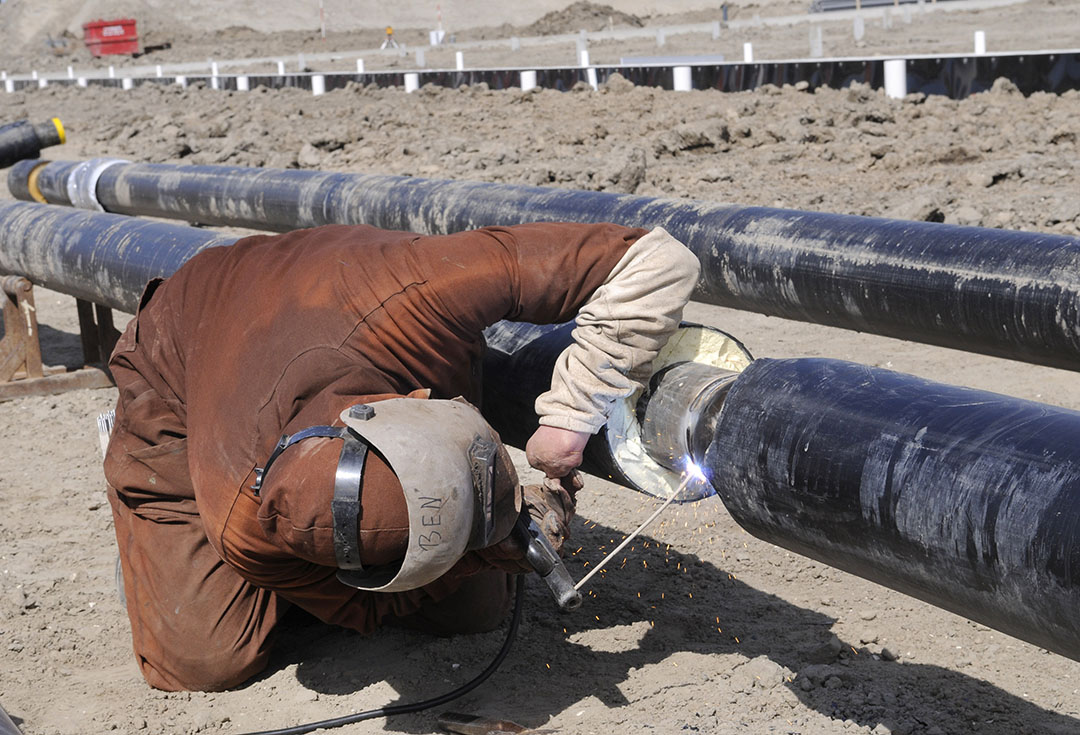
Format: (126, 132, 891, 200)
(476, 472, 583, 574)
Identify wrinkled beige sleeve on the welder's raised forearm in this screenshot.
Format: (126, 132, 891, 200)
(536, 228, 701, 434)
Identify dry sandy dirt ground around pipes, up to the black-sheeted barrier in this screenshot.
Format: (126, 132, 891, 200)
(0, 2, 1080, 735)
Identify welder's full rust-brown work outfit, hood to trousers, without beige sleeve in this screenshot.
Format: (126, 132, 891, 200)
(105, 223, 645, 690)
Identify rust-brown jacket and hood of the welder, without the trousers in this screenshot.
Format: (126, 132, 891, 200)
(107, 223, 645, 630)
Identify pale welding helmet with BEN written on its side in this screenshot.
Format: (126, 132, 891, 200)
(334, 398, 522, 593)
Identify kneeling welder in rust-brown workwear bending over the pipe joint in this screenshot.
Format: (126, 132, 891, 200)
(105, 222, 699, 691)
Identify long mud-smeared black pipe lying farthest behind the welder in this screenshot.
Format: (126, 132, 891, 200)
(9, 163, 1080, 370)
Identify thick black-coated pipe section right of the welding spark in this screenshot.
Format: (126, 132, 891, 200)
(703, 359, 1080, 659)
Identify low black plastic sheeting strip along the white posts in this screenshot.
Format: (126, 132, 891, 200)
(4, 51, 1080, 99)
